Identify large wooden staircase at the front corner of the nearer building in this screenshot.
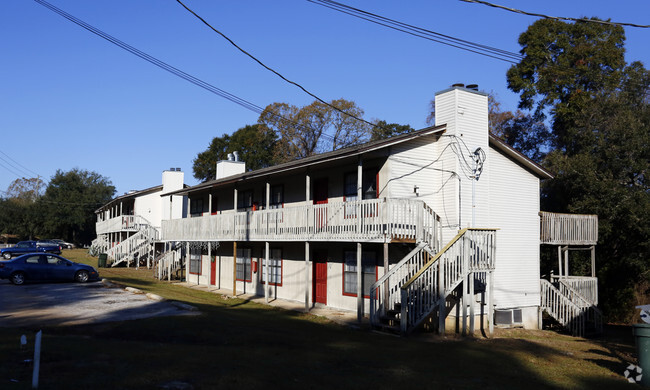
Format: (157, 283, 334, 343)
(370, 228, 496, 334)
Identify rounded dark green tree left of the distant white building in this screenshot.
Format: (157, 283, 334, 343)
(41, 168, 115, 244)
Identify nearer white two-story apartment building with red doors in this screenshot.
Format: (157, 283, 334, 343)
(161, 87, 568, 331)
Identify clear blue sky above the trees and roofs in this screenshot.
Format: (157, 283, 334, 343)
(0, 0, 650, 195)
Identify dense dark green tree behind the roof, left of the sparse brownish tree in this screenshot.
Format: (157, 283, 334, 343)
(192, 124, 277, 181)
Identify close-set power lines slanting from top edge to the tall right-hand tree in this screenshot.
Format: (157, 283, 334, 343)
(307, 0, 522, 64)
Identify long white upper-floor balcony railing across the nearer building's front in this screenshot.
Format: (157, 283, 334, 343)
(161, 198, 440, 248)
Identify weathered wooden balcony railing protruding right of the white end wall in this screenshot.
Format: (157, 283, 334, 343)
(539, 211, 598, 245)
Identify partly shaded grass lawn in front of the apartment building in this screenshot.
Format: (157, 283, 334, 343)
(0, 249, 637, 390)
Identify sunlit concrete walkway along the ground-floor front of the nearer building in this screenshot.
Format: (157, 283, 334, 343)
(179, 282, 362, 328)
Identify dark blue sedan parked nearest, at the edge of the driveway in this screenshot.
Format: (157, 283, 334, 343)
(0, 253, 99, 284)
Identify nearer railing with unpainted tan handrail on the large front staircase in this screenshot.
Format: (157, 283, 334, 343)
(400, 228, 496, 333)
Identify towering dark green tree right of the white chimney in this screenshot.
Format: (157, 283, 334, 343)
(507, 20, 650, 320)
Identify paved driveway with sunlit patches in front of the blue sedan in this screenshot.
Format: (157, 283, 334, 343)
(0, 280, 198, 328)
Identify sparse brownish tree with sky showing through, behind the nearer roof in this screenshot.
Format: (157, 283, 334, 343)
(258, 99, 370, 162)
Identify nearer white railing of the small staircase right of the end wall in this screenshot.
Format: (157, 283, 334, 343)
(540, 279, 586, 337)
